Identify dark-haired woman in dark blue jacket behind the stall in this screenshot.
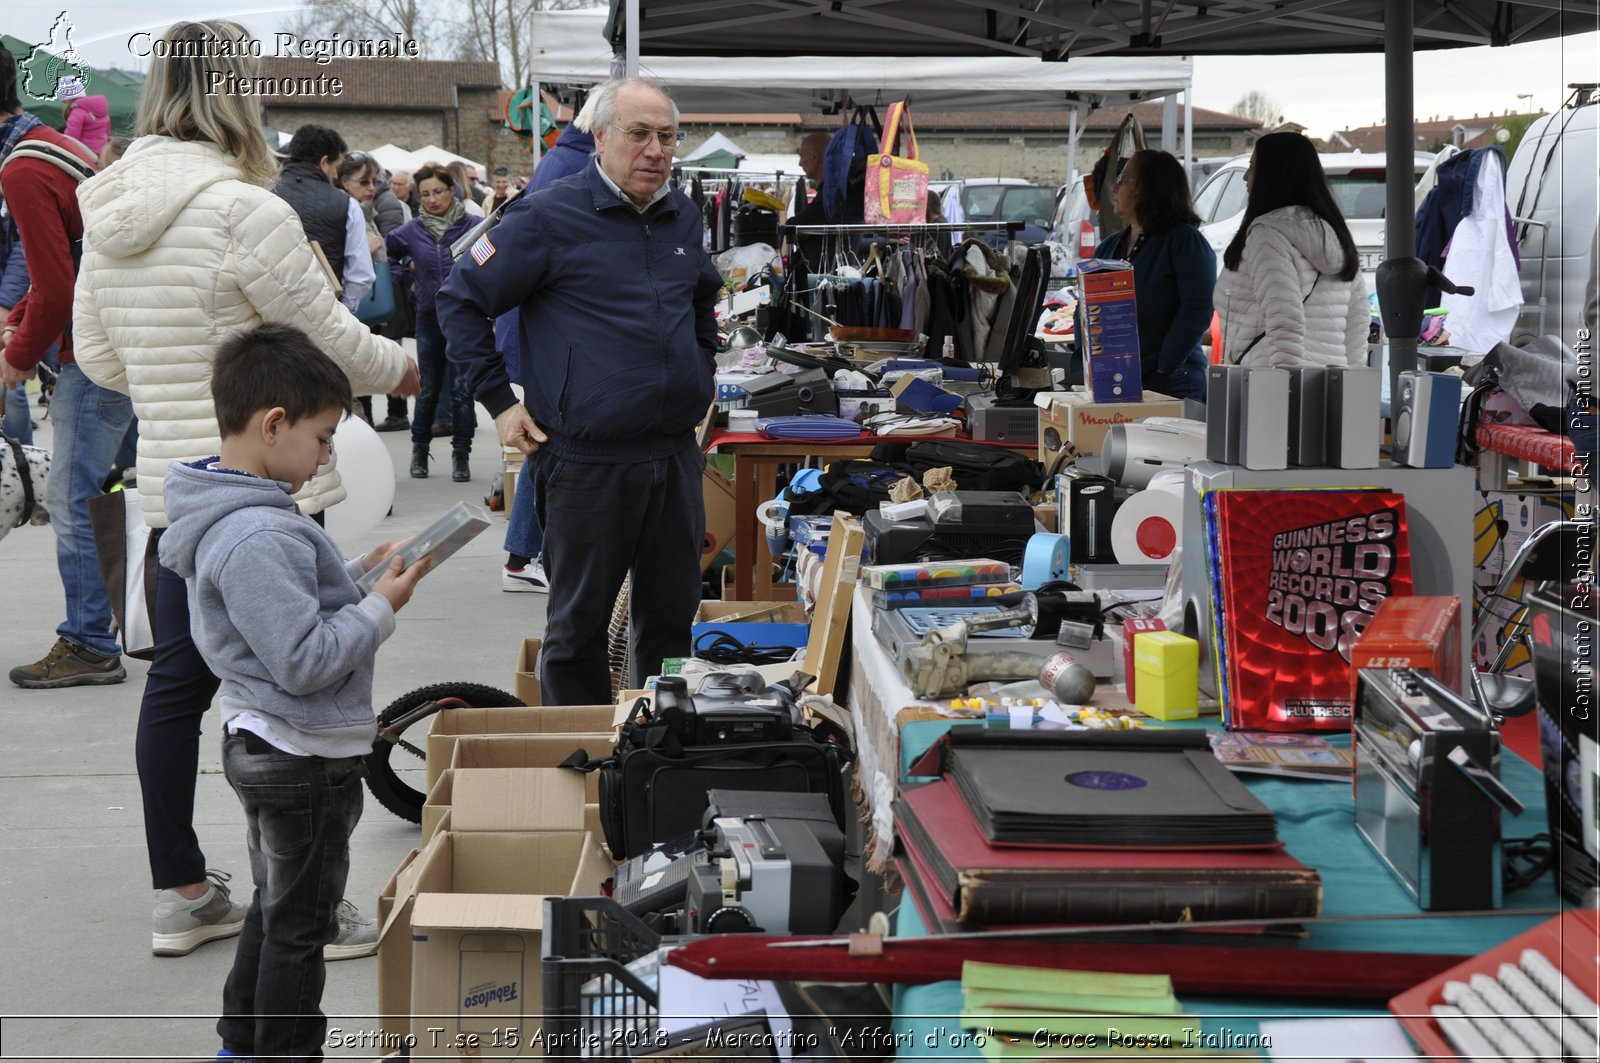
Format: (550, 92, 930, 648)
(1094, 150, 1216, 402)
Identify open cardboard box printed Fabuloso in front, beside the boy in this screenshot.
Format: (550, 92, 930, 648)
(378, 772, 613, 1057)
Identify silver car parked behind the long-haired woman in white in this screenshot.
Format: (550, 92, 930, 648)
(1195, 152, 1434, 280)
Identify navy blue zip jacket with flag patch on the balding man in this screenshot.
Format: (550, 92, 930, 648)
(437, 165, 722, 464)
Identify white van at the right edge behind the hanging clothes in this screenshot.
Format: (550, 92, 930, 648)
(1506, 85, 1600, 344)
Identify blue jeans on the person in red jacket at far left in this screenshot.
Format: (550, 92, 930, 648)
(45, 362, 133, 656)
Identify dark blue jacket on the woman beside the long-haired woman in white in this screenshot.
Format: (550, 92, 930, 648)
(1094, 224, 1216, 376)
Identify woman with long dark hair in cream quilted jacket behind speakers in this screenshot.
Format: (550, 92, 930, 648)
(1213, 133, 1371, 365)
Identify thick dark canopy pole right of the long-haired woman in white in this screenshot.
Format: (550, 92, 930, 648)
(1379, 0, 1422, 395)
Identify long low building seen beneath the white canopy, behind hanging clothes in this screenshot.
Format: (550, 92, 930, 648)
(683, 102, 1261, 187)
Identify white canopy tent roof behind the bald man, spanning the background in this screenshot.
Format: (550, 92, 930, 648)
(528, 10, 1194, 176)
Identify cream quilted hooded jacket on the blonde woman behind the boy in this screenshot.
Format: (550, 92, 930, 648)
(72, 136, 406, 528)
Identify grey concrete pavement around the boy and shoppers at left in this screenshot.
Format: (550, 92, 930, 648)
(0, 400, 546, 1060)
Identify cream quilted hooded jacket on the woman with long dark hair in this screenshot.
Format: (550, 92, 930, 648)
(1213, 207, 1371, 365)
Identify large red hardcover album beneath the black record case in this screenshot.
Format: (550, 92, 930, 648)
(894, 780, 1322, 924)
